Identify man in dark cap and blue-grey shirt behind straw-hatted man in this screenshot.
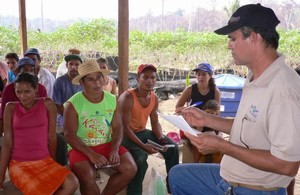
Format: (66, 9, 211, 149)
(53, 54, 82, 133)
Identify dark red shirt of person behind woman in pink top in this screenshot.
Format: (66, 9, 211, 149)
(0, 83, 48, 120)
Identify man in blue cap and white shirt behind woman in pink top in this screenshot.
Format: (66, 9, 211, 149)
(24, 48, 55, 97)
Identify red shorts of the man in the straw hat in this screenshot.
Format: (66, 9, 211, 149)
(68, 142, 128, 168)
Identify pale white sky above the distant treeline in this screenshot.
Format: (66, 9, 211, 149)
(0, 0, 300, 21)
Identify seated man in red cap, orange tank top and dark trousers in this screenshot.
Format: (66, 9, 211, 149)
(118, 64, 179, 195)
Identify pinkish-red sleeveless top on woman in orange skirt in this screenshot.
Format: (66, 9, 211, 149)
(12, 99, 50, 161)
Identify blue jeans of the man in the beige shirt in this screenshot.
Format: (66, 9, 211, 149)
(169, 163, 286, 195)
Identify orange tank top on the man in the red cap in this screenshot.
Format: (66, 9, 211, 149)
(128, 89, 155, 132)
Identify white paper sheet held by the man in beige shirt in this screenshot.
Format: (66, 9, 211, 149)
(157, 112, 201, 136)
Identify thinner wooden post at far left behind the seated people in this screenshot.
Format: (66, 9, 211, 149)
(19, 0, 27, 56)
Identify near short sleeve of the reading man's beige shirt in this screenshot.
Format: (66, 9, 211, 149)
(267, 94, 300, 161)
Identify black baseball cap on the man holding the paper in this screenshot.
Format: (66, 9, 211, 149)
(215, 3, 280, 35)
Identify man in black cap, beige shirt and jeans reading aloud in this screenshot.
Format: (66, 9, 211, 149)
(169, 4, 300, 195)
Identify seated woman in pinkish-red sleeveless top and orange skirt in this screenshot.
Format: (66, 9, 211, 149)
(0, 72, 78, 194)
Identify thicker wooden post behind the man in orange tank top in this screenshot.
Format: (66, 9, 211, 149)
(118, 0, 129, 95)
